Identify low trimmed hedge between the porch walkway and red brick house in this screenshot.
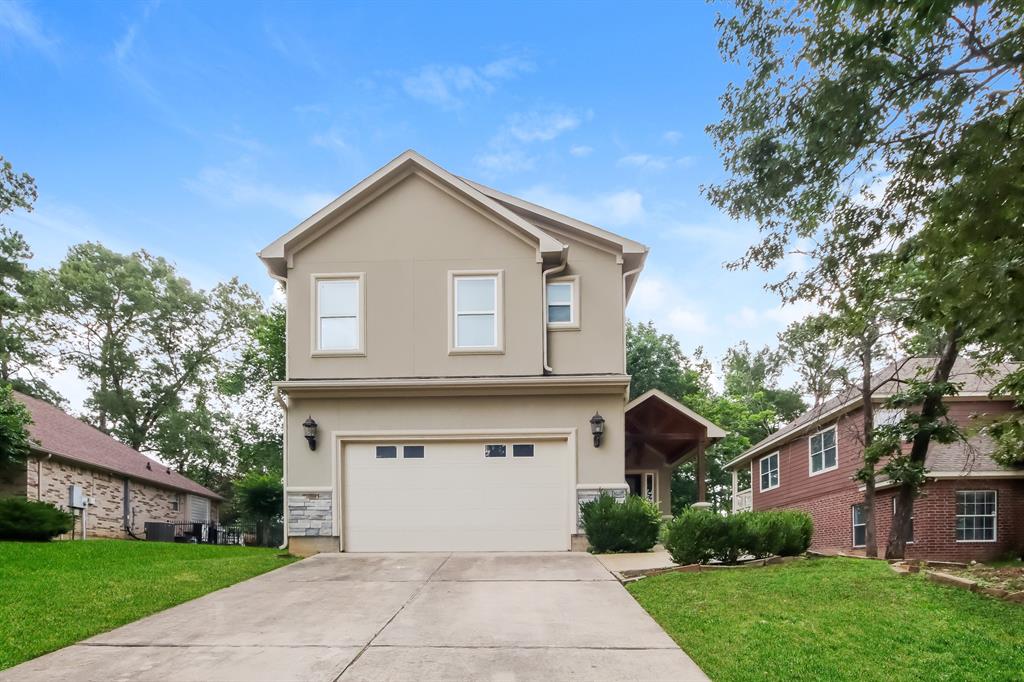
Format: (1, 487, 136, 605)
(665, 509, 814, 564)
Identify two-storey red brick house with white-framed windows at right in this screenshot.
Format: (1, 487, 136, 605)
(726, 359, 1024, 561)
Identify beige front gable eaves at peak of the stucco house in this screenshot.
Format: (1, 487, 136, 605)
(259, 150, 567, 278)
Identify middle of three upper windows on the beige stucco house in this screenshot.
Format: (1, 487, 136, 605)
(449, 271, 503, 352)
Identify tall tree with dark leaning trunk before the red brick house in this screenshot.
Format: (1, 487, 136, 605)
(707, 0, 1024, 556)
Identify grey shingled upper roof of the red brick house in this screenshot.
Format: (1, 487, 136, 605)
(724, 357, 1018, 469)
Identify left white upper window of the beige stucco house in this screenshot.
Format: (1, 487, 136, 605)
(313, 273, 362, 354)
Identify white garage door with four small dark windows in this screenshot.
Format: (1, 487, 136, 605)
(342, 439, 570, 552)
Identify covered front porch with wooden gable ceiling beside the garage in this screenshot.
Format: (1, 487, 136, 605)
(625, 388, 725, 515)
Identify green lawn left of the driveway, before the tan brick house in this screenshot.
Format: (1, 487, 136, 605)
(0, 540, 295, 670)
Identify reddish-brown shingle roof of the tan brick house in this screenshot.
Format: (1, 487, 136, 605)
(14, 391, 222, 500)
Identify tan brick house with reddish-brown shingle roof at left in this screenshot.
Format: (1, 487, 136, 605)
(0, 392, 221, 538)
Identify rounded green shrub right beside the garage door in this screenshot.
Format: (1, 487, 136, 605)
(580, 493, 662, 554)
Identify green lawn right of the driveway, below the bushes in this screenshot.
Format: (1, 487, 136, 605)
(628, 558, 1024, 682)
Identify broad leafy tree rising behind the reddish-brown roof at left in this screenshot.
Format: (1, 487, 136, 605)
(42, 243, 259, 457)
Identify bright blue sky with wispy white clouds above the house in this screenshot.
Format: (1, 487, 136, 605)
(0, 0, 801, 401)
